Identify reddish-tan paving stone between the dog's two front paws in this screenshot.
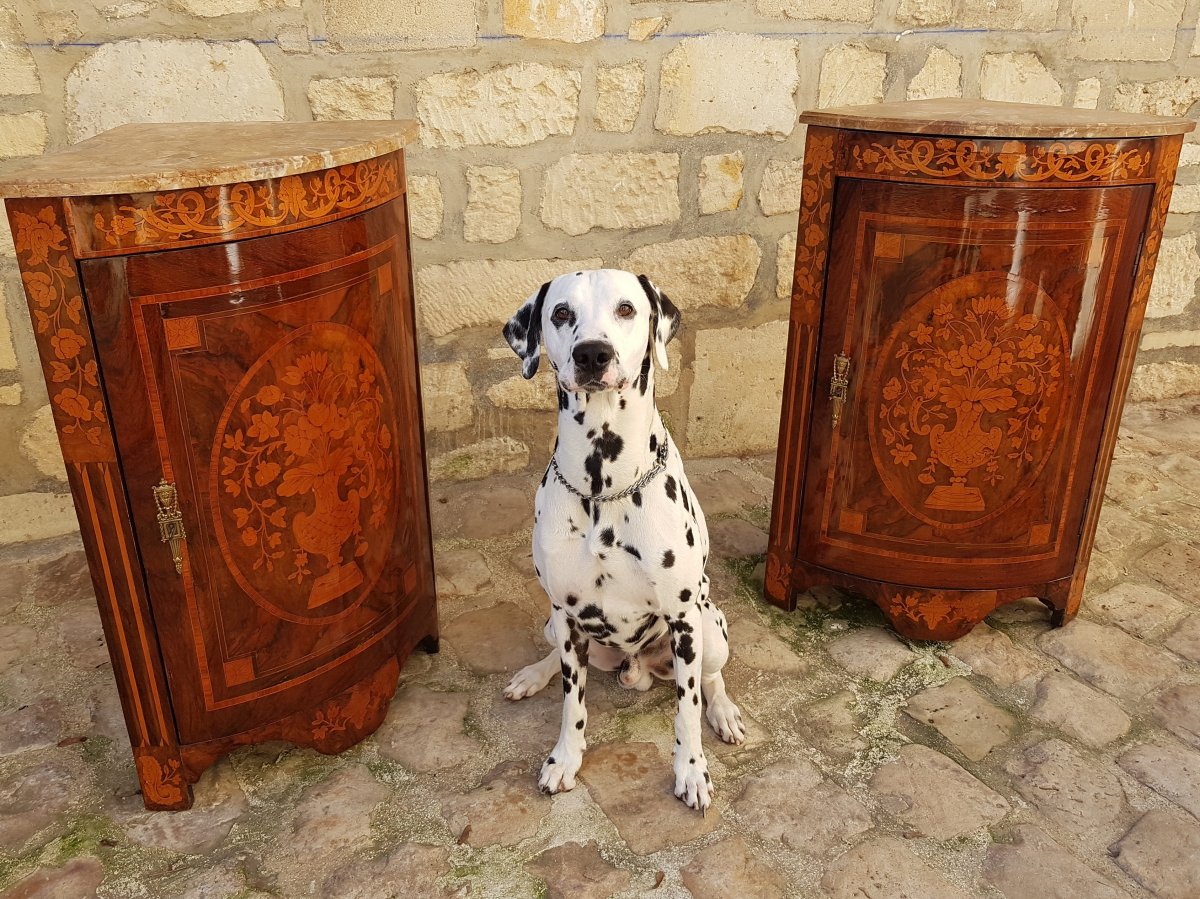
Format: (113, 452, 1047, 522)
(580, 743, 721, 856)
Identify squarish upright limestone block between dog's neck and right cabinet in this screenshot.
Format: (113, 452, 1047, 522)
(688, 322, 787, 456)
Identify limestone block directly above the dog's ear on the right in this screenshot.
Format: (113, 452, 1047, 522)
(622, 234, 762, 311)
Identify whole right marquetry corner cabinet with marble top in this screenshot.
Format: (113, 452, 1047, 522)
(766, 100, 1194, 640)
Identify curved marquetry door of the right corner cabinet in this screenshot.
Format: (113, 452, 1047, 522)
(799, 180, 1151, 588)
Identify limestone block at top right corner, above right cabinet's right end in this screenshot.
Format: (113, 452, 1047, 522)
(1068, 0, 1184, 61)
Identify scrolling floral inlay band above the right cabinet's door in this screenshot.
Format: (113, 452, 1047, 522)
(850, 138, 1154, 182)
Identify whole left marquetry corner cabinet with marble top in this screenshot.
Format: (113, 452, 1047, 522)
(0, 122, 438, 809)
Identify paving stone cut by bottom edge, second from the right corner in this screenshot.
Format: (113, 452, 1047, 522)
(983, 825, 1129, 899)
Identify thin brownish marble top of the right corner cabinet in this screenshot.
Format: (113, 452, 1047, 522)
(800, 98, 1196, 138)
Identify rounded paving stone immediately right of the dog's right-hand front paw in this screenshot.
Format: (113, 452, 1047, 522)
(733, 759, 871, 858)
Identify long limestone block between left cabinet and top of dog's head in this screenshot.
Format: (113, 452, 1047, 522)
(416, 258, 602, 340)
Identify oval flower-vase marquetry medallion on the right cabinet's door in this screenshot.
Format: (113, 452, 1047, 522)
(868, 271, 1070, 528)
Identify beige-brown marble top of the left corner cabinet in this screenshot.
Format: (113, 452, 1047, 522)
(0, 120, 416, 197)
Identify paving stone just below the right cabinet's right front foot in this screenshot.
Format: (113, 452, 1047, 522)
(1038, 618, 1178, 702)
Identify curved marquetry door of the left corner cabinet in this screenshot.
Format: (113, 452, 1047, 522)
(83, 200, 433, 743)
